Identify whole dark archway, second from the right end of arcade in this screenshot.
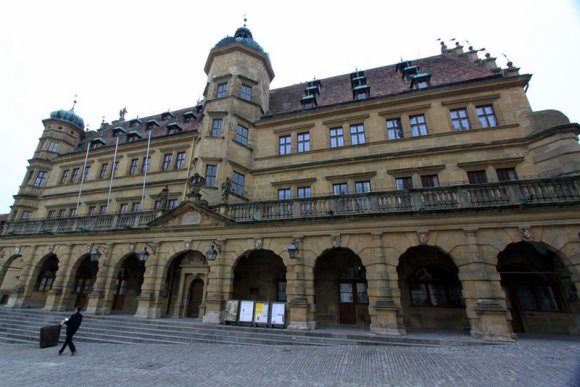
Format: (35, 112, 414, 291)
(397, 245, 470, 331)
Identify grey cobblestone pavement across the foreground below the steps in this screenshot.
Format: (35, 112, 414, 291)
(0, 337, 580, 387)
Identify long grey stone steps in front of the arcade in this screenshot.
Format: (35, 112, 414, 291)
(0, 307, 489, 346)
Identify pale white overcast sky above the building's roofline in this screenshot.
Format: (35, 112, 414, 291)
(0, 0, 580, 214)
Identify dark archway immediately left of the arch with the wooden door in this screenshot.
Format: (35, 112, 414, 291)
(111, 253, 145, 314)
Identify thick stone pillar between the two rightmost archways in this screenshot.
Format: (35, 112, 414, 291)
(458, 229, 513, 341)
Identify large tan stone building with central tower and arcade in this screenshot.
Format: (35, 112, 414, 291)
(0, 26, 580, 340)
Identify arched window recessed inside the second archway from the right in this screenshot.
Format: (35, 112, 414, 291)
(409, 265, 463, 307)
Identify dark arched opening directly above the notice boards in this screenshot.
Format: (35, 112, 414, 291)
(231, 249, 286, 302)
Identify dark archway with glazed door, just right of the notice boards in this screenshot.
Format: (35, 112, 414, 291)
(314, 248, 370, 327)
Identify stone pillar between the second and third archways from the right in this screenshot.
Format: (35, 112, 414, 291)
(365, 232, 406, 335)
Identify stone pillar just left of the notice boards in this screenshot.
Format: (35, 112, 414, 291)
(202, 239, 228, 324)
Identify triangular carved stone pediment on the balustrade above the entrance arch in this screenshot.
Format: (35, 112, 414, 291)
(149, 201, 231, 228)
